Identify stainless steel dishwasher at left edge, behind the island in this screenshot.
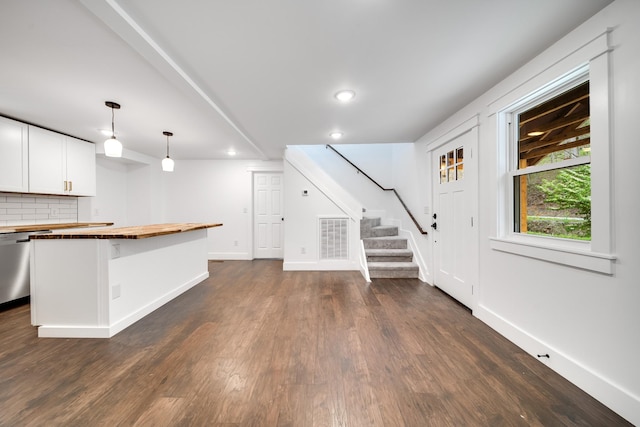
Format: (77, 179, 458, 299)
(0, 231, 50, 304)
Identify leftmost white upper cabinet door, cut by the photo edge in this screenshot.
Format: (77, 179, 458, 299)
(0, 117, 29, 193)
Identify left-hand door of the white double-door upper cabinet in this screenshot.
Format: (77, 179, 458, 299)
(29, 126, 65, 194)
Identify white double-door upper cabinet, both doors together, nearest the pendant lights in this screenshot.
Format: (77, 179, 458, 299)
(29, 126, 96, 196)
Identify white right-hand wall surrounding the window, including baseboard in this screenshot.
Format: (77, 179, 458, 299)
(408, 0, 640, 424)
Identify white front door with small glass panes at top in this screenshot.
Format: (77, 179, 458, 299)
(431, 128, 477, 307)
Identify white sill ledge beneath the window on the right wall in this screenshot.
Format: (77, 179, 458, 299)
(490, 237, 616, 275)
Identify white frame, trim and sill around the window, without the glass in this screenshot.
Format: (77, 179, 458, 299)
(489, 31, 616, 274)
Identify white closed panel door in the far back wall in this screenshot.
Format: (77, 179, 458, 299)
(253, 173, 284, 259)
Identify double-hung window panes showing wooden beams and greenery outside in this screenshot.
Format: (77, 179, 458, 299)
(511, 79, 591, 241)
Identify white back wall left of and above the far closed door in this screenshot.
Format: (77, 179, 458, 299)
(163, 160, 286, 259)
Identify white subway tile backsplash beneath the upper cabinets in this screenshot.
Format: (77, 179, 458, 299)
(0, 193, 78, 225)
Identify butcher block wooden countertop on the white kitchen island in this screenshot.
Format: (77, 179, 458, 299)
(29, 222, 222, 239)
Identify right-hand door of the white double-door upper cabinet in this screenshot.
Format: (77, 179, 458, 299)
(66, 137, 96, 196)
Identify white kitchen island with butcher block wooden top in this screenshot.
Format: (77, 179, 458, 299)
(30, 223, 222, 338)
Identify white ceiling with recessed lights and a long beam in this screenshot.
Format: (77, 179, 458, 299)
(0, 0, 611, 160)
